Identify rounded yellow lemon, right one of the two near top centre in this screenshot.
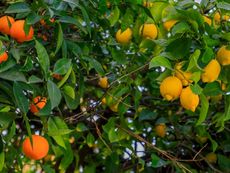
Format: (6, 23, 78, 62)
(139, 23, 157, 39)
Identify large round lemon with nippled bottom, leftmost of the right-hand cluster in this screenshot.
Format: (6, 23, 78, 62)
(160, 76, 182, 101)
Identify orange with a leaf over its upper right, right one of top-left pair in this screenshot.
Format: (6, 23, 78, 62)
(10, 20, 34, 43)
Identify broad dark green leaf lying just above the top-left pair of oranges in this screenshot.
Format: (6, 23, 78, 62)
(5, 2, 31, 14)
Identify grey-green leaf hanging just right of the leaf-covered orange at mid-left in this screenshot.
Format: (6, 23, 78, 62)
(47, 80, 61, 109)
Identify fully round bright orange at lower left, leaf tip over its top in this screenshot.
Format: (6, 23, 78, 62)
(22, 135, 49, 160)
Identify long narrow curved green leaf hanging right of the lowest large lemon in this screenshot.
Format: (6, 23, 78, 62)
(196, 93, 209, 126)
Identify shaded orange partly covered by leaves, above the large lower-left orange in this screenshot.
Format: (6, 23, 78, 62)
(30, 96, 47, 114)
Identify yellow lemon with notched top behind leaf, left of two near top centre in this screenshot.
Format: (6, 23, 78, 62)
(116, 28, 132, 44)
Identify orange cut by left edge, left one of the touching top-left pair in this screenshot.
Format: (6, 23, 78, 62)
(0, 16, 14, 35)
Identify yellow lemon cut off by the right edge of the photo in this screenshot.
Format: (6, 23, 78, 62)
(216, 46, 230, 65)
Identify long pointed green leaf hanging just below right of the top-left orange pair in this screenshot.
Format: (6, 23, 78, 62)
(35, 40, 50, 79)
